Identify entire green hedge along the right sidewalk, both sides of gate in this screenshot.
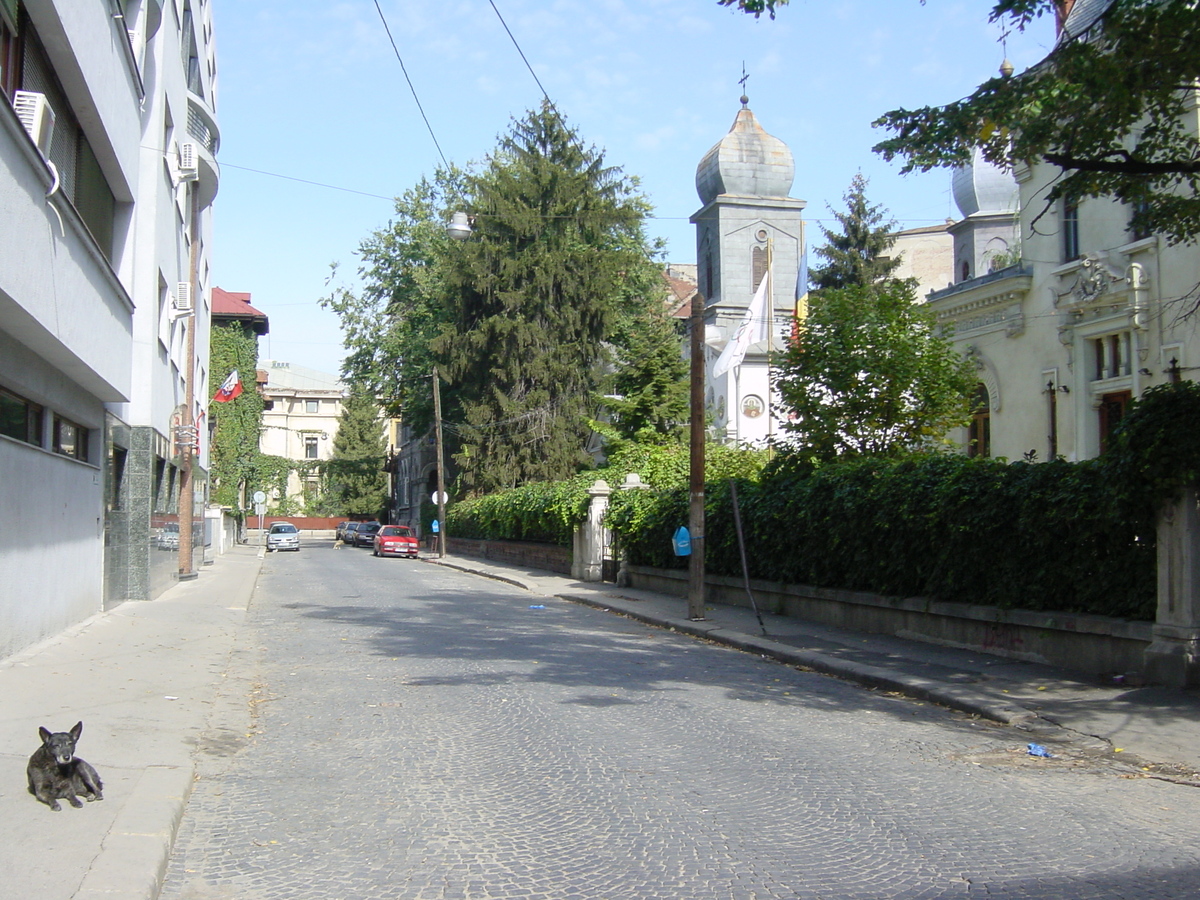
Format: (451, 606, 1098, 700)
(448, 382, 1200, 620)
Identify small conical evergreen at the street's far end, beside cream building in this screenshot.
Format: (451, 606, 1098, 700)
(325, 388, 388, 516)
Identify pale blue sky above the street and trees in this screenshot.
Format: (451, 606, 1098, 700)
(214, 0, 1052, 372)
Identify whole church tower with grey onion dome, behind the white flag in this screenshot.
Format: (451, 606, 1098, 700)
(691, 96, 806, 445)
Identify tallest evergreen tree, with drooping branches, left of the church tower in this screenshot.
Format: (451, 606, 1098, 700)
(434, 102, 648, 492)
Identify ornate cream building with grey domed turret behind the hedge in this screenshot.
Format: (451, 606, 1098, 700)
(930, 139, 1200, 461)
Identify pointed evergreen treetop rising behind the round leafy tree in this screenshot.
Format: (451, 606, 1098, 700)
(810, 173, 900, 289)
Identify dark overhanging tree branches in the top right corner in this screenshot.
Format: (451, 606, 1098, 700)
(875, 0, 1200, 244)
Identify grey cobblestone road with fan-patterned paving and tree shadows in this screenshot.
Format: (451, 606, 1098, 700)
(162, 541, 1200, 900)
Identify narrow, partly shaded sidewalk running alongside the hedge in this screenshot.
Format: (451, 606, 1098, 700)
(428, 557, 1200, 786)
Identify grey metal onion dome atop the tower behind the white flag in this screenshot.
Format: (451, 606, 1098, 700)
(696, 97, 796, 204)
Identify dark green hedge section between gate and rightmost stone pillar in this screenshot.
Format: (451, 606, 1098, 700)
(610, 456, 1154, 619)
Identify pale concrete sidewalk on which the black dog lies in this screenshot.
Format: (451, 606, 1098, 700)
(0, 546, 262, 900)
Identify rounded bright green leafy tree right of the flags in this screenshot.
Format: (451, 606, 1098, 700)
(776, 280, 976, 461)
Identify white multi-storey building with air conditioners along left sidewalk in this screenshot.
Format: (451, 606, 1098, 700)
(0, 0, 217, 656)
